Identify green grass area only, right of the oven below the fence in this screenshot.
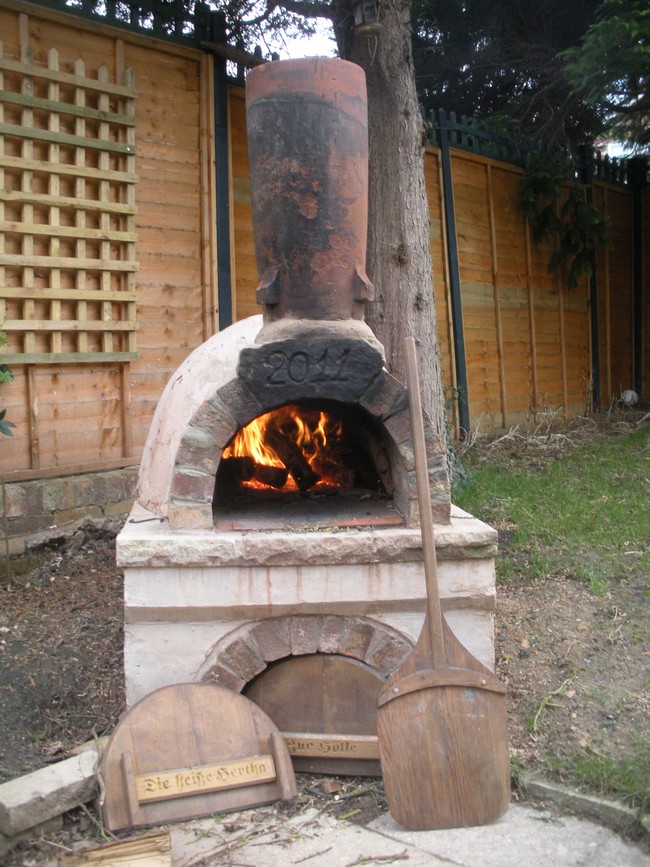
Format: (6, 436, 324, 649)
(454, 428, 650, 593)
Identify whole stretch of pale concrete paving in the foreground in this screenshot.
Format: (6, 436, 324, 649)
(159, 804, 650, 867)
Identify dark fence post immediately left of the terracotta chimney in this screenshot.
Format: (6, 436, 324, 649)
(210, 12, 233, 330)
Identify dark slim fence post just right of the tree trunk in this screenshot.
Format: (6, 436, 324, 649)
(438, 109, 469, 437)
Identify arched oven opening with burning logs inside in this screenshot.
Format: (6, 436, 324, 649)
(213, 399, 402, 526)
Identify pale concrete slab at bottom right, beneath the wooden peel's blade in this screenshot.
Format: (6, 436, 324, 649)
(368, 804, 650, 867)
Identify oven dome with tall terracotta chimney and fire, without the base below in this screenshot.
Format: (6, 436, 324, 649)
(132, 60, 449, 529)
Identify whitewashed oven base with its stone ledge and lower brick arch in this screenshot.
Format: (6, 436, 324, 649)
(117, 505, 497, 706)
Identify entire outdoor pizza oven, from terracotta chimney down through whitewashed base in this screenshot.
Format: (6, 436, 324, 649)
(117, 59, 496, 768)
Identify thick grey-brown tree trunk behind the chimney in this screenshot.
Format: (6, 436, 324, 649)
(333, 0, 445, 440)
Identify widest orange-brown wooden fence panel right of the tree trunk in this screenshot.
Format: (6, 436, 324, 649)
(440, 150, 591, 431)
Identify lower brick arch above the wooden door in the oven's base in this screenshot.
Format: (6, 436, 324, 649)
(197, 614, 413, 692)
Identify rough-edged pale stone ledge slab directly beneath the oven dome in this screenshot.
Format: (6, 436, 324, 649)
(117, 504, 498, 568)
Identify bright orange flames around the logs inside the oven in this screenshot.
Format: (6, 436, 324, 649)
(222, 404, 343, 490)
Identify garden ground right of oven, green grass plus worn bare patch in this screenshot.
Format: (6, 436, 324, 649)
(453, 421, 650, 811)
